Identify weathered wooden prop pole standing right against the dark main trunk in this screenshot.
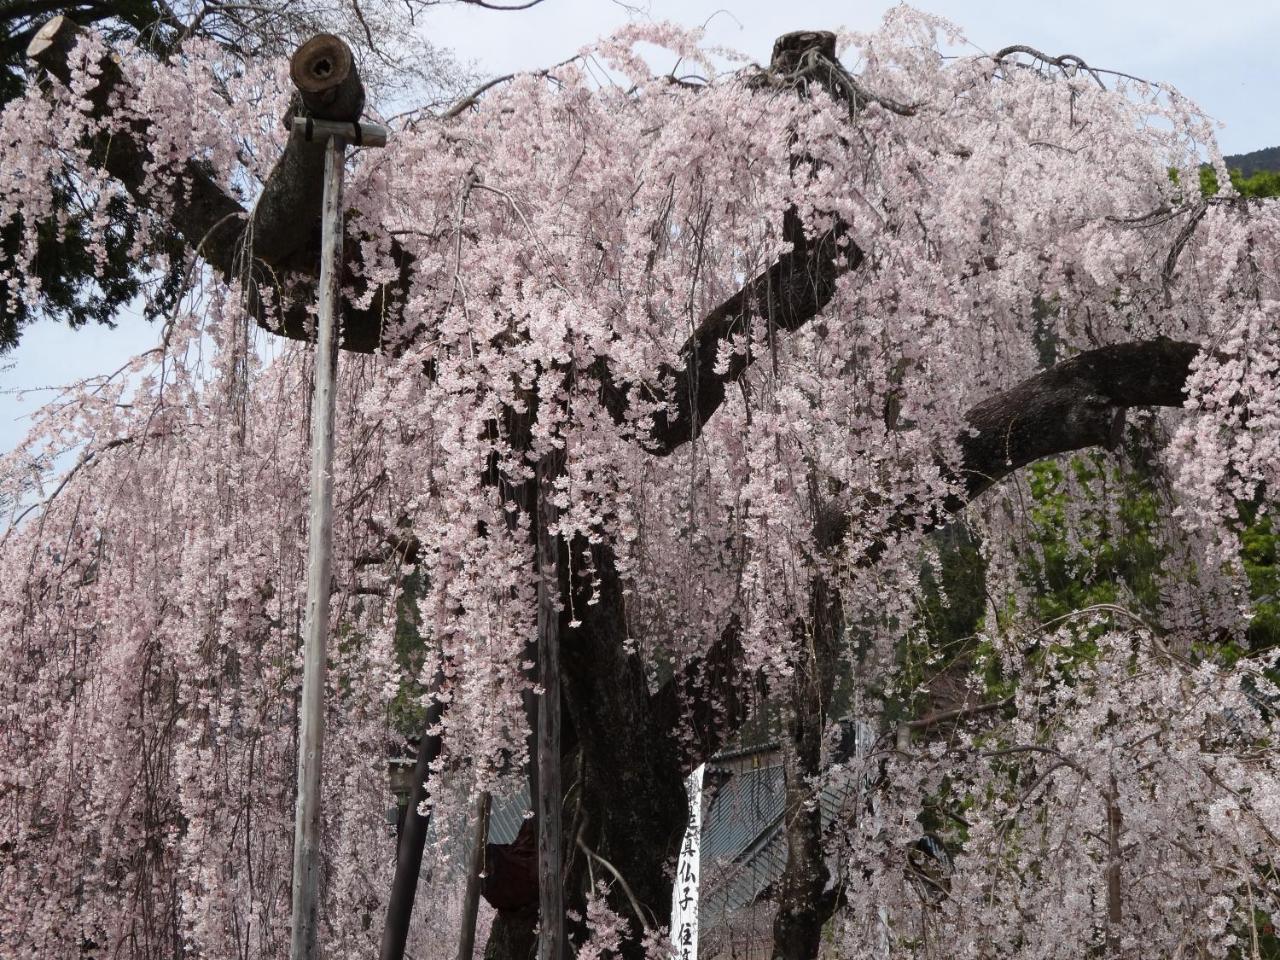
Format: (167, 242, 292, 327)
(534, 457, 566, 960)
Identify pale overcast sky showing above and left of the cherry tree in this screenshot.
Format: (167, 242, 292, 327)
(0, 0, 1280, 451)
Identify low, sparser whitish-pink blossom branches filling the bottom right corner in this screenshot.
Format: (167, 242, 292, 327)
(828, 624, 1280, 957)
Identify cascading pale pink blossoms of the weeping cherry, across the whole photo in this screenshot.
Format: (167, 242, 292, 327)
(0, 8, 1280, 957)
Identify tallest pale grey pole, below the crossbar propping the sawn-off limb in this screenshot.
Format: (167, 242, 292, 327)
(289, 136, 346, 960)
